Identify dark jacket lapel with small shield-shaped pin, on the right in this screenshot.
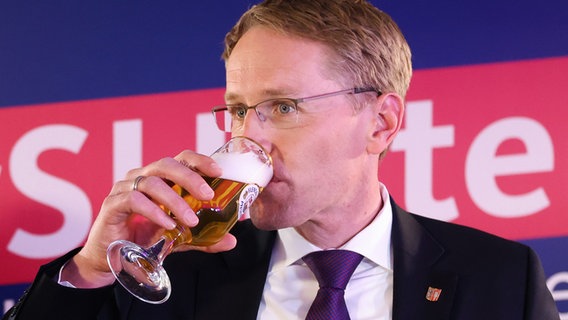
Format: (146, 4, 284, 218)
(391, 200, 458, 320)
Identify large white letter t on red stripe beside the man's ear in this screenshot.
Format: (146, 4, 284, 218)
(391, 100, 459, 221)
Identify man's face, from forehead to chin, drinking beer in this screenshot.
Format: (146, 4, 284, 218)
(226, 26, 377, 230)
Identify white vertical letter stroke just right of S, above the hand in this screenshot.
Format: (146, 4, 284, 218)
(112, 119, 142, 182)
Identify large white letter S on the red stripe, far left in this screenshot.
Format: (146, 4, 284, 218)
(8, 125, 92, 259)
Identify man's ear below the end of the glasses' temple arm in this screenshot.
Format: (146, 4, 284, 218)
(367, 92, 404, 154)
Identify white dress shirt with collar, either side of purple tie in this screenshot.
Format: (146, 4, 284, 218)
(258, 184, 393, 320)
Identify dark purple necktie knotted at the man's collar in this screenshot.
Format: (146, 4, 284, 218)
(303, 250, 363, 320)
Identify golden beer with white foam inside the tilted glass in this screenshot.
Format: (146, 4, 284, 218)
(163, 149, 272, 247)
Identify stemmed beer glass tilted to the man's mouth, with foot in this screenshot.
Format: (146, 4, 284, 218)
(107, 137, 273, 304)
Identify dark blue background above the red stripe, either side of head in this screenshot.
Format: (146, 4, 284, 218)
(0, 0, 568, 106)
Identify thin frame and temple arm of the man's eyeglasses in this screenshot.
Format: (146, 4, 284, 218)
(211, 87, 382, 133)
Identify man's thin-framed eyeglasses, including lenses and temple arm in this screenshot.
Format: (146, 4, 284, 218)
(211, 88, 382, 133)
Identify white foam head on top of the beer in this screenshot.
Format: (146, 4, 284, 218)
(211, 153, 273, 188)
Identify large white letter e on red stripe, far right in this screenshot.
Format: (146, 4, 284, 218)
(465, 117, 554, 218)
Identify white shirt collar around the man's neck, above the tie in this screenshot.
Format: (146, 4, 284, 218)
(272, 183, 392, 271)
